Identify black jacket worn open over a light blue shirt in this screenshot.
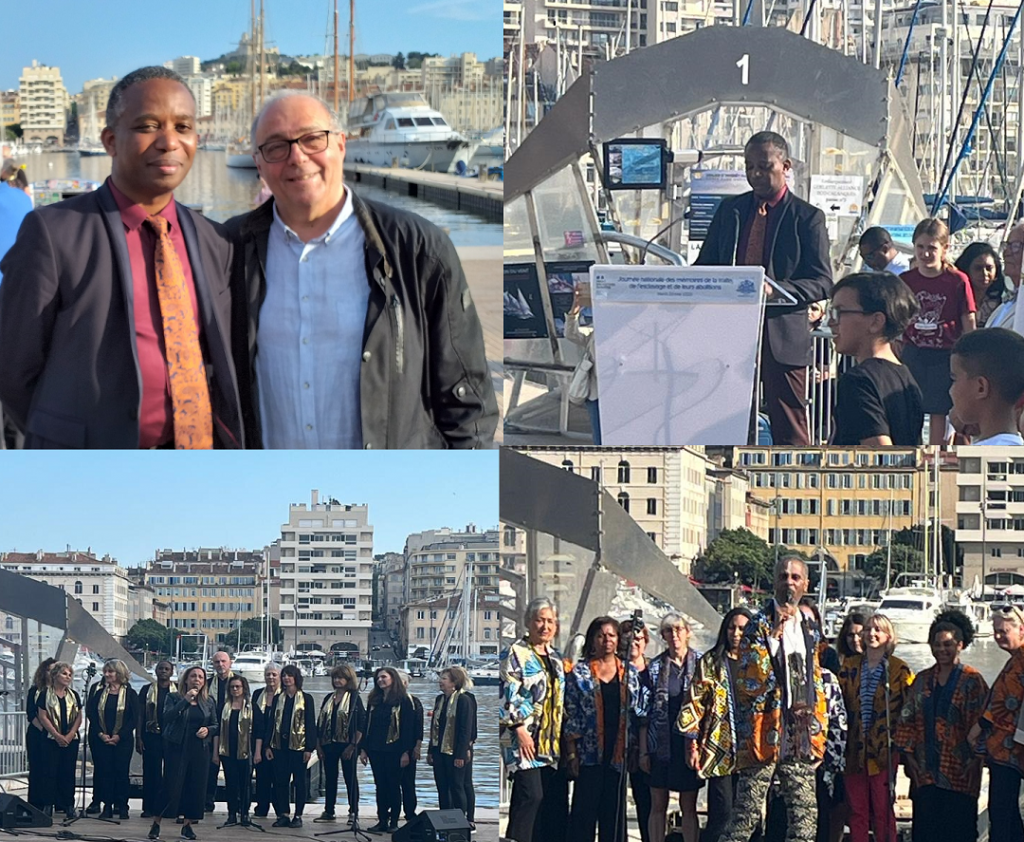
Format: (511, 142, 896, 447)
(223, 193, 498, 450)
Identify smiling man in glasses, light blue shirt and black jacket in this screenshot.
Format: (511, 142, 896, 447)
(227, 94, 498, 450)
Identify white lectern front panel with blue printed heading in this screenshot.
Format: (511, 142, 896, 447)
(590, 265, 764, 447)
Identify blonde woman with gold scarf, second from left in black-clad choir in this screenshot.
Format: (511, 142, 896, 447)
(37, 662, 82, 818)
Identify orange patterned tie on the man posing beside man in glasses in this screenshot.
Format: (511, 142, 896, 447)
(146, 216, 213, 451)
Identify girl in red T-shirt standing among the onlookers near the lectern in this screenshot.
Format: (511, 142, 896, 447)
(900, 219, 977, 445)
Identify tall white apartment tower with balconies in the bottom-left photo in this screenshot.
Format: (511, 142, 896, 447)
(280, 490, 374, 656)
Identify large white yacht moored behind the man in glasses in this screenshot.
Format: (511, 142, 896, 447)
(345, 91, 469, 172)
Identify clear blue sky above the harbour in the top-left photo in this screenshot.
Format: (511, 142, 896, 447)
(0, 0, 502, 94)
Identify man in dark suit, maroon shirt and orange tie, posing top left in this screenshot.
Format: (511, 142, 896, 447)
(0, 68, 243, 449)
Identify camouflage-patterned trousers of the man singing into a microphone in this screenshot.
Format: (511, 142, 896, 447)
(722, 759, 818, 842)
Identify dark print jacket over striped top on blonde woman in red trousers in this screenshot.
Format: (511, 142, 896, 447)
(839, 655, 913, 774)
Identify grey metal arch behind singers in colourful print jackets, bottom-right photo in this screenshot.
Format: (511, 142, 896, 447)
(499, 448, 722, 634)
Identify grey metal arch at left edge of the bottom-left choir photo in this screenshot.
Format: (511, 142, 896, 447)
(0, 570, 153, 684)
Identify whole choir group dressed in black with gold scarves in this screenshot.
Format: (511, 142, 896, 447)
(26, 651, 479, 839)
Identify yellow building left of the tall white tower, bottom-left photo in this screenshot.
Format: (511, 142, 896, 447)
(143, 547, 265, 644)
